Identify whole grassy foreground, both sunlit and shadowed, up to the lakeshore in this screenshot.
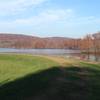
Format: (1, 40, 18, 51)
(0, 54, 100, 100)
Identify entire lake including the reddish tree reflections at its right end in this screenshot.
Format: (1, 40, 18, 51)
(0, 48, 100, 61)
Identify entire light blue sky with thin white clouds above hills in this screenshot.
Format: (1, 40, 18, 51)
(0, 0, 100, 38)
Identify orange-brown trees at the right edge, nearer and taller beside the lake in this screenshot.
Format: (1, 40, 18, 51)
(79, 32, 100, 61)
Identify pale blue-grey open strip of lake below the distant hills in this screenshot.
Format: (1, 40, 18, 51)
(0, 48, 80, 55)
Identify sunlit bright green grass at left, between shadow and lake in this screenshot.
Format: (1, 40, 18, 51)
(0, 54, 58, 85)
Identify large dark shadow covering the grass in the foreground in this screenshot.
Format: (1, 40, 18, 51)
(0, 67, 100, 100)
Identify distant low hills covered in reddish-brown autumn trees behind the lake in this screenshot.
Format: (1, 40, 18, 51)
(0, 33, 78, 48)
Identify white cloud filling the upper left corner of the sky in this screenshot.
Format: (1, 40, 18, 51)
(0, 0, 46, 16)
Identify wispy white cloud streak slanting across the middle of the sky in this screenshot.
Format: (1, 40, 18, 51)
(1, 9, 73, 26)
